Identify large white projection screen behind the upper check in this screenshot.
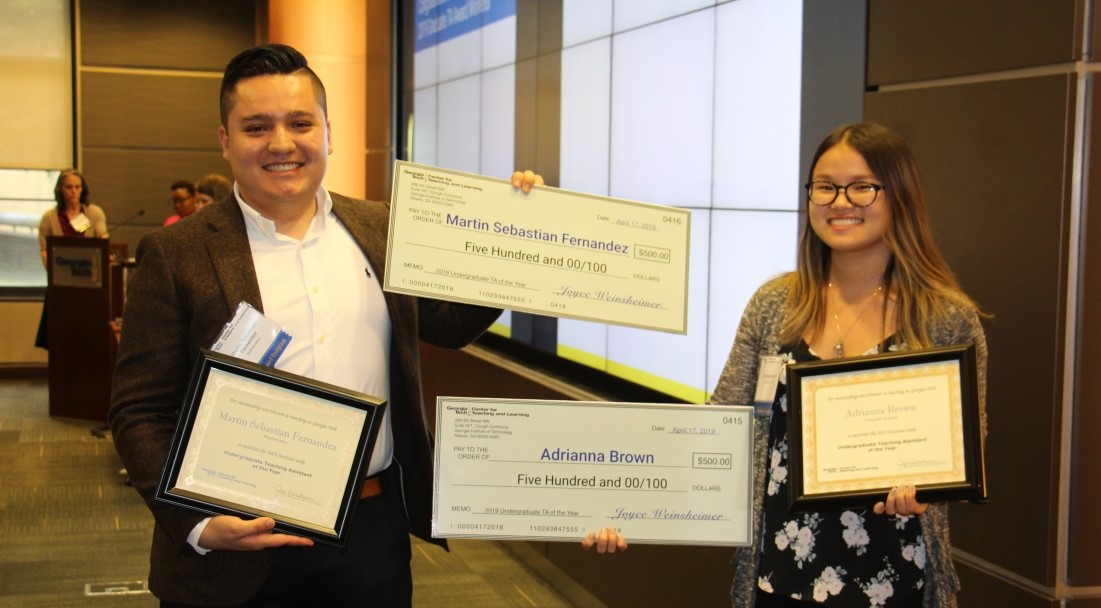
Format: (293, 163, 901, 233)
(405, 0, 804, 403)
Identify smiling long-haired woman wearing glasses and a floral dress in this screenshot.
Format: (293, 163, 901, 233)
(712, 123, 986, 608)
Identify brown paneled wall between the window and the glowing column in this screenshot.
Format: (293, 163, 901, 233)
(74, 0, 258, 252)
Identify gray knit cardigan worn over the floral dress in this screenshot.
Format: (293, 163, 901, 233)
(711, 278, 986, 608)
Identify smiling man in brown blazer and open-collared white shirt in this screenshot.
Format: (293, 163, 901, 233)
(110, 45, 517, 607)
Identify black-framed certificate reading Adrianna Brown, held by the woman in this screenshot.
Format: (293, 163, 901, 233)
(787, 345, 986, 510)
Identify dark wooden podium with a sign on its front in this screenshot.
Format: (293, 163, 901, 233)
(45, 237, 126, 423)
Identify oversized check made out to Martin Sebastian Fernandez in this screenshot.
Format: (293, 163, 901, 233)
(383, 161, 691, 334)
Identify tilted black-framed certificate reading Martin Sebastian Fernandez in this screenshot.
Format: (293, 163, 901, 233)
(156, 349, 385, 546)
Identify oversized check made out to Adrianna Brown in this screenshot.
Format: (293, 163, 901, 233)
(432, 397, 753, 545)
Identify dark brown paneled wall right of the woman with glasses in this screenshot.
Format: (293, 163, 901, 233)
(864, 0, 1101, 608)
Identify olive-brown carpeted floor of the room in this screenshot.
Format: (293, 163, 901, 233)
(0, 379, 600, 608)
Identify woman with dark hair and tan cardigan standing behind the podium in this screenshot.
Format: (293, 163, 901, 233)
(34, 169, 109, 348)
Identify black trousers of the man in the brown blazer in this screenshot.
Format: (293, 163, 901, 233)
(161, 467, 413, 608)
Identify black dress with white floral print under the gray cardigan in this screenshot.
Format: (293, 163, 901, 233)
(757, 338, 925, 608)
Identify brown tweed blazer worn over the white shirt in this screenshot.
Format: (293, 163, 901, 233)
(109, 194, 500, 606)
